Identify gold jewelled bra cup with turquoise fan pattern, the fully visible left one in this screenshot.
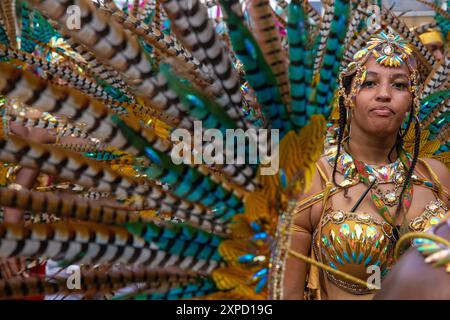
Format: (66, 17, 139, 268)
(313, 211, 394, 294)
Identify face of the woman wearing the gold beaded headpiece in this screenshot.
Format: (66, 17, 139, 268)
(351, 57, 412, 136)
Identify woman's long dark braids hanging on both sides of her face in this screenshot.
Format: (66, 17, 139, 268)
(332, 70, 420, 220)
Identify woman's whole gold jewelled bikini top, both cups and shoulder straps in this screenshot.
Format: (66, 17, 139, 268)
(301, 159, 448, 295)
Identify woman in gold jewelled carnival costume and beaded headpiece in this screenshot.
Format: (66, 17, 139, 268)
(284, 32, 450, 299)
